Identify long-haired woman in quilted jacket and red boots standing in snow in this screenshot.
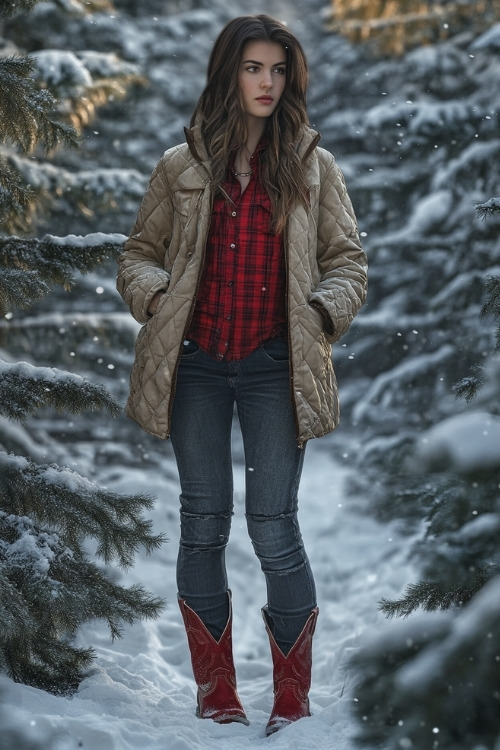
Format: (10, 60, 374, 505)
(118, 15, 366, 734)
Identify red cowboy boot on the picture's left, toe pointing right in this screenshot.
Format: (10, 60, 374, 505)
(178, 591, 249, 724)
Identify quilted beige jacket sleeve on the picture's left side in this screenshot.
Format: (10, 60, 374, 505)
(116, 161, 173, 324)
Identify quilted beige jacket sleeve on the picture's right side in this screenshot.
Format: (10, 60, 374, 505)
(309, 149, 367, 343)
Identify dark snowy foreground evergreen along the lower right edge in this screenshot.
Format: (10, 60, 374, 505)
(353, 198, 500, 750)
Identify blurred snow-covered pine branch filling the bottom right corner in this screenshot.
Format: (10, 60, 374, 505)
(350, 575, 500, 750)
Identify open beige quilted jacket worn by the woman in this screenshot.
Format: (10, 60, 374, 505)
(117, 126, 366, 446)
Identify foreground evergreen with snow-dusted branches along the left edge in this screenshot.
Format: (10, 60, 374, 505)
(0, 2, 163, 693)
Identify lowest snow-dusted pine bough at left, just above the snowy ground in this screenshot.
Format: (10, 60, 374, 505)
(0, 512, 164, 693)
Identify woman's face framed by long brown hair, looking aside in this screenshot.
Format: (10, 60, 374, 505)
(238, 41, 286, 118)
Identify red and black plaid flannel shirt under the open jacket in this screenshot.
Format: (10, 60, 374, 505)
(187, 143, 287, 360)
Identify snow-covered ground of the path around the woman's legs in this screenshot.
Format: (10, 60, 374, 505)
(0, 434, 414, 750)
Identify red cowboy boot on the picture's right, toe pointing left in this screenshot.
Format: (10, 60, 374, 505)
(262, 607, 318, 736)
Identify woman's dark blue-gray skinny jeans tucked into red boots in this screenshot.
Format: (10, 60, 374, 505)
(171, 339, 316, 653)
